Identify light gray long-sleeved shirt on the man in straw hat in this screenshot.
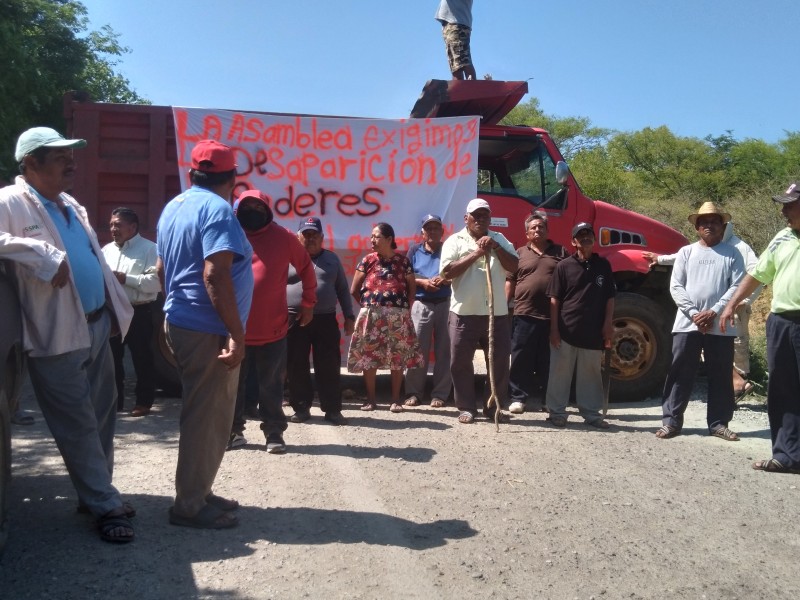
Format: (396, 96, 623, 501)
(669, 242, 745, 337)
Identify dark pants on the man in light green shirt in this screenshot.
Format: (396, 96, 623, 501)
(767, 313, 800, 469)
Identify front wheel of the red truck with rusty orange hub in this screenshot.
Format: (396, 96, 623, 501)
(609, 292, 672, 402)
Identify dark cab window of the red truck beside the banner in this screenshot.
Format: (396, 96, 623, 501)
(478, 137, 566, 209)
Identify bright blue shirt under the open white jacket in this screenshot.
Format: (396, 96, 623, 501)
(34, 190, 106, 315)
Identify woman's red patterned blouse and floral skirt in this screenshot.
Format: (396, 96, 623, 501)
(347, 252, 424, 373)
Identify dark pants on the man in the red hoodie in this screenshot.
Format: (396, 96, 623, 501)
(231, 337, 288, 435)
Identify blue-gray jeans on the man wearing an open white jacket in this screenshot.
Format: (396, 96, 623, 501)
(28, 311, 122, 517)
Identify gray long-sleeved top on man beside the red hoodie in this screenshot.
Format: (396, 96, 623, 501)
(286, 250, 354, 319)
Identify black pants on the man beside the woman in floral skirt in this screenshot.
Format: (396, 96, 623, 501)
(286, 313, 342, 413)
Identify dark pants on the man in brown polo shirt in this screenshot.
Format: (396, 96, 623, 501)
(509, 315, 550, 406)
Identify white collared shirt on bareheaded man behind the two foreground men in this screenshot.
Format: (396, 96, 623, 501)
(103, 233, 161, 304)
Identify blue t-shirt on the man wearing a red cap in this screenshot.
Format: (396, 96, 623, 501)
(156, 186, 253, 335)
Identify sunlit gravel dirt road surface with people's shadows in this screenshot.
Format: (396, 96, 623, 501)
(0, 376, 800, 600)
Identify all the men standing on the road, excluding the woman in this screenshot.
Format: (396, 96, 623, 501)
(0, 127, 800, 542)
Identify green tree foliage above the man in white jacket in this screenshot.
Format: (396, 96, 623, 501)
(0, 0, 145, 178)
